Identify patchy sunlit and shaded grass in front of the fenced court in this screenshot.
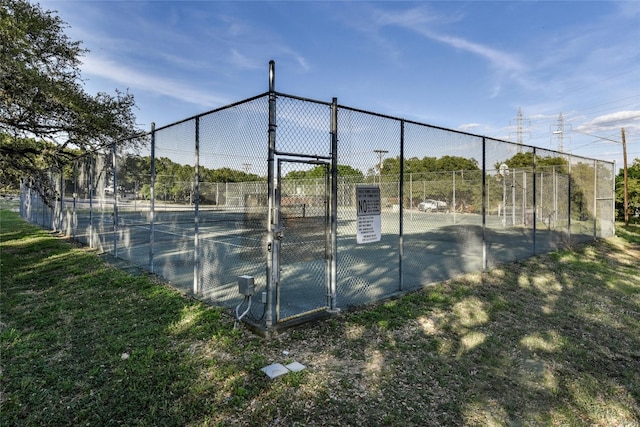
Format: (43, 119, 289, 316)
(0, 211, 640, 427)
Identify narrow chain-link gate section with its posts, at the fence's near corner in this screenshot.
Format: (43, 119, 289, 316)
(265, 65, 338, 329)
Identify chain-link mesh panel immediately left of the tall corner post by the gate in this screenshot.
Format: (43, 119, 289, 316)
(198, 97, 268, 314)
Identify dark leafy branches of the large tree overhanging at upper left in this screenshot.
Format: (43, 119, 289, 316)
(0, 0, 139, 199)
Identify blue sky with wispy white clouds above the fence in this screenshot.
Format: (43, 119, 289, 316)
(40, 0, 640, 167)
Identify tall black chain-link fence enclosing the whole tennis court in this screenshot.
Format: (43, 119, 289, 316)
(21, 92, 615, 329)
